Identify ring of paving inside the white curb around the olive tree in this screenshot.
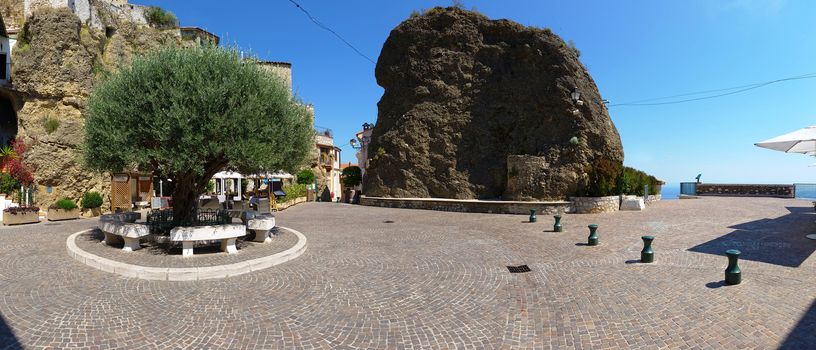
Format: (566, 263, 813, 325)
(76, 230, 298, 268)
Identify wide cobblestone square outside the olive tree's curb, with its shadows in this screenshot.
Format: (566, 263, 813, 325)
(0, 198, 816, 349)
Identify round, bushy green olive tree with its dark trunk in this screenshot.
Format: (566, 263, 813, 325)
(84, 46, 314, 222)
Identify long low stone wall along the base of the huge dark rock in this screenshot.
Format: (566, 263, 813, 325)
(360, 196, 571, 215)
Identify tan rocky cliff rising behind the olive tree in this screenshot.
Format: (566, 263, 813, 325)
(6, 1, 186, 205)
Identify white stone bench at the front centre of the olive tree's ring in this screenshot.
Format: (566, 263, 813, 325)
(170, 224, 246, 256)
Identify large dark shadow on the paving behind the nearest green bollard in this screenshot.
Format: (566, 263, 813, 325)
(689, 207, 816, 267)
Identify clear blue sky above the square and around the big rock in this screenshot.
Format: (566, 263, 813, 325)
(140, 0, 816, 183)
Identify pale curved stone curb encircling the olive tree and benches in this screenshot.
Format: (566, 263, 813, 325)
(66, 226, 306, 281)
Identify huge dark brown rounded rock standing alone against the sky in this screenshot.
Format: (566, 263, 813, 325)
(364, 8, 623, 200)
